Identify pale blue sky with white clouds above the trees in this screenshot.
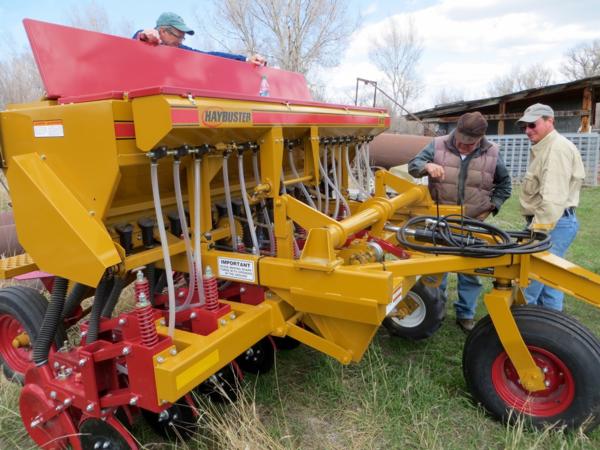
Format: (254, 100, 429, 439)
(0, 0, 600, 110)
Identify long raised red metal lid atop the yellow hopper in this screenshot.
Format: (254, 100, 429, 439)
(23, 19, 312, 102)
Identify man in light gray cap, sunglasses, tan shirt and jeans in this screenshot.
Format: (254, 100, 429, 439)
(517, 103, 585, 311)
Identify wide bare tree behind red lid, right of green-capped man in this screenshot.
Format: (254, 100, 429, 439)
(202, 0, 356, 74)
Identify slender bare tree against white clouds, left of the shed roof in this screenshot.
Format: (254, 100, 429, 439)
(370, 18, 423, 116)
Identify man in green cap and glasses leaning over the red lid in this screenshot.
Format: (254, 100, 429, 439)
(133, 12, 267, 66)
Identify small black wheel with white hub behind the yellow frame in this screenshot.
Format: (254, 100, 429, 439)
(383, 281, 446, 341)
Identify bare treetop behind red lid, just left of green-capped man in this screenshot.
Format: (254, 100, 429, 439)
(67, 0, 135, 37)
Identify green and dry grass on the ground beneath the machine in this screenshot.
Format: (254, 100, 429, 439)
(0, 188, 600, 449)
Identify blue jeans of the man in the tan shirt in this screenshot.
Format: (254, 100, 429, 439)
(525, 212, 579, 311)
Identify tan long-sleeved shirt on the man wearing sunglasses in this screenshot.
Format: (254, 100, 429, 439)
(519, 130, 585, 228)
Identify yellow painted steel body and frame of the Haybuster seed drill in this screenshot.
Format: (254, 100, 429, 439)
(0, 95, 600, 402)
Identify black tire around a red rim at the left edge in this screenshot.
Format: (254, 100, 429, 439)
(0, 286, 66, 384)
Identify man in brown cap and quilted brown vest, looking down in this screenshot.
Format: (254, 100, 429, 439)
(408, 112, 512, 332)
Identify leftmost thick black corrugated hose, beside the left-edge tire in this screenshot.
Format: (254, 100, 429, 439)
(32, 277, 69, 366)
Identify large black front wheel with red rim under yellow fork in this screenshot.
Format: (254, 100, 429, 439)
(463, 306, 600, 430)
